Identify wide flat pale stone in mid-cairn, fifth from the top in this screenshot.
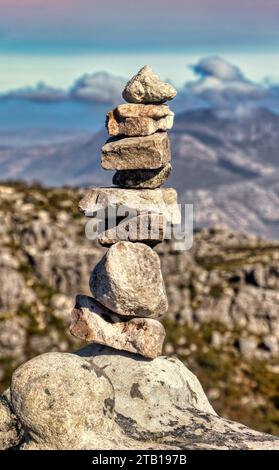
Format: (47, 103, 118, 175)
(79, 188, 181, 224)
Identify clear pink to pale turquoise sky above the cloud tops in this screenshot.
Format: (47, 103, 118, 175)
(0, 0, 279, 91)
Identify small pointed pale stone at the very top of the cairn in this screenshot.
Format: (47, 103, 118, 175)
(122, 65, 176, 104)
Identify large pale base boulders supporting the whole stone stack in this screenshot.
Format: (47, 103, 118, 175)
(0, 346, 279, 450)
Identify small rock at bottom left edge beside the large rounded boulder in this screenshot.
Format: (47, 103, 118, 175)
(0, 395, 23, 450)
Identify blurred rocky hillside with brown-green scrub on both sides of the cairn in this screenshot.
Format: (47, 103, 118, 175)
(0, 185, 279, 433)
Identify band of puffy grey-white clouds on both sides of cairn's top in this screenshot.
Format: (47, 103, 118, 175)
(0, 56, 279, 116)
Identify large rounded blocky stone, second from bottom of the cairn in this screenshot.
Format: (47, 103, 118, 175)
(90, 242, 168, 318)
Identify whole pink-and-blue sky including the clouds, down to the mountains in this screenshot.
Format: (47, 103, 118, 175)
(0, 0, 279, 132)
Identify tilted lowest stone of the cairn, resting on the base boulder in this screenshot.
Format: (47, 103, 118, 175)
(70, 295, 165, 358)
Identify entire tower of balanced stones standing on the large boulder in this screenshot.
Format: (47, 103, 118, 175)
(70, 66, 180, 358)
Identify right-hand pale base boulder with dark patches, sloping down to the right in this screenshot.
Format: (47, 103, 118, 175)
(77, 345, 279, 450)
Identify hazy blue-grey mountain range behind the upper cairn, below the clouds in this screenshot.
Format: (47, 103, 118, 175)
(0, 108, 279, 238)
